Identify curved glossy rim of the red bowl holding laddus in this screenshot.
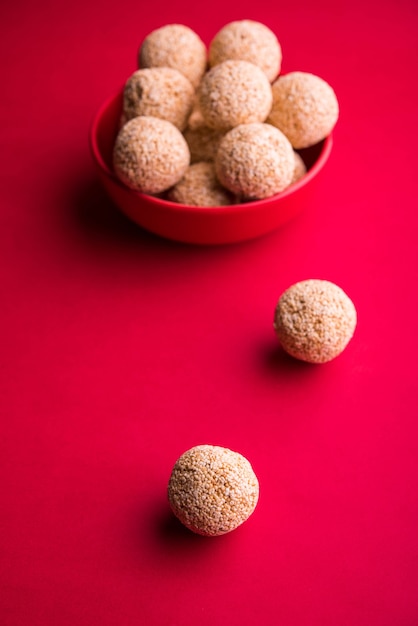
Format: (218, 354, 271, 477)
(89, 88, 333, 214)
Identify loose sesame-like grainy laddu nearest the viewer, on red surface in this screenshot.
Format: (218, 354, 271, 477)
(168, 445, 259, 536)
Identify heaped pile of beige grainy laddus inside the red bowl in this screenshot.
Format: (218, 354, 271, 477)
(113, 20, 339, 206)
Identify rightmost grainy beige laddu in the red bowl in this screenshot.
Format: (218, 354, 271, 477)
(267, 72, 339, 149)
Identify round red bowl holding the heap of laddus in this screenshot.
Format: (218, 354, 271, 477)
(90, 92, 332, 244)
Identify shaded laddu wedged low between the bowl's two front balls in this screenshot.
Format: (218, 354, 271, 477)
(167, 161, 234, 206)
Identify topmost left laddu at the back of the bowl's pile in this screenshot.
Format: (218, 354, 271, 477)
(138, 24, 207, 88)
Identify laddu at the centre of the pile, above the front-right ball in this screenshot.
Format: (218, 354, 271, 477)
(198, 61, 273, 131)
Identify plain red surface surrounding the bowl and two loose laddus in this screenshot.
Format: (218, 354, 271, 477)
(0, 0, 418, 626)
